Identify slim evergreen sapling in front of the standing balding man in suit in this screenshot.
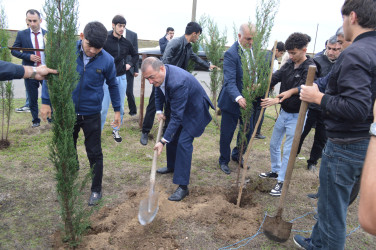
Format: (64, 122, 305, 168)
(238, 0, 279, 157)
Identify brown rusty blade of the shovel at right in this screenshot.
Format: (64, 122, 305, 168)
(263, 216, 292, 242)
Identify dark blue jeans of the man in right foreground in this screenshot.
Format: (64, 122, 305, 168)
(311, 139, 369, 249)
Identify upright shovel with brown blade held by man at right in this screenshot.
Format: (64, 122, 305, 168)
(263, 65, 316, 242)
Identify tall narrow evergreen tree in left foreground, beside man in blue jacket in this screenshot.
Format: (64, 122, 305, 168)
(44, 0, 92, 246)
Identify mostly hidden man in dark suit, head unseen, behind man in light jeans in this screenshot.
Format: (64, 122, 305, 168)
(125, 25, 138, 116)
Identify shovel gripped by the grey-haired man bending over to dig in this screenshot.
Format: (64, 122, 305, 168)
(138, 120, 164, 226)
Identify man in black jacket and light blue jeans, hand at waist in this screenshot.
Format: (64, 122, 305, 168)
(101, 15, 138, 142)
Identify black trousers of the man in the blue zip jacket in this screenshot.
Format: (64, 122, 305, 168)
(73, 113, 103, 192)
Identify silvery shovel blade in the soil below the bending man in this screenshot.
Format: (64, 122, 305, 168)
(138, 193, 158, 226)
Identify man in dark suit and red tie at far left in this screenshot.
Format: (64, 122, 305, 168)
(11, 9, 47, 128)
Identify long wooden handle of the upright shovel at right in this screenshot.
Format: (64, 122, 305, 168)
(277, 65, 316, 211)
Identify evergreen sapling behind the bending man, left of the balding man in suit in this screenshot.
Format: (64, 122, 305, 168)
(202, 17, 227, 123)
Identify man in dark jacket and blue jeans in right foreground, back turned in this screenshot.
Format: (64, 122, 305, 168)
(294, 0, 376, 249)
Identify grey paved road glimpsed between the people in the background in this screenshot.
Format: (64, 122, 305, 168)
(13, 71, 210, 98)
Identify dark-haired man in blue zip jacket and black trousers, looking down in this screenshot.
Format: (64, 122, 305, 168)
(41, 22, 120, 206)
